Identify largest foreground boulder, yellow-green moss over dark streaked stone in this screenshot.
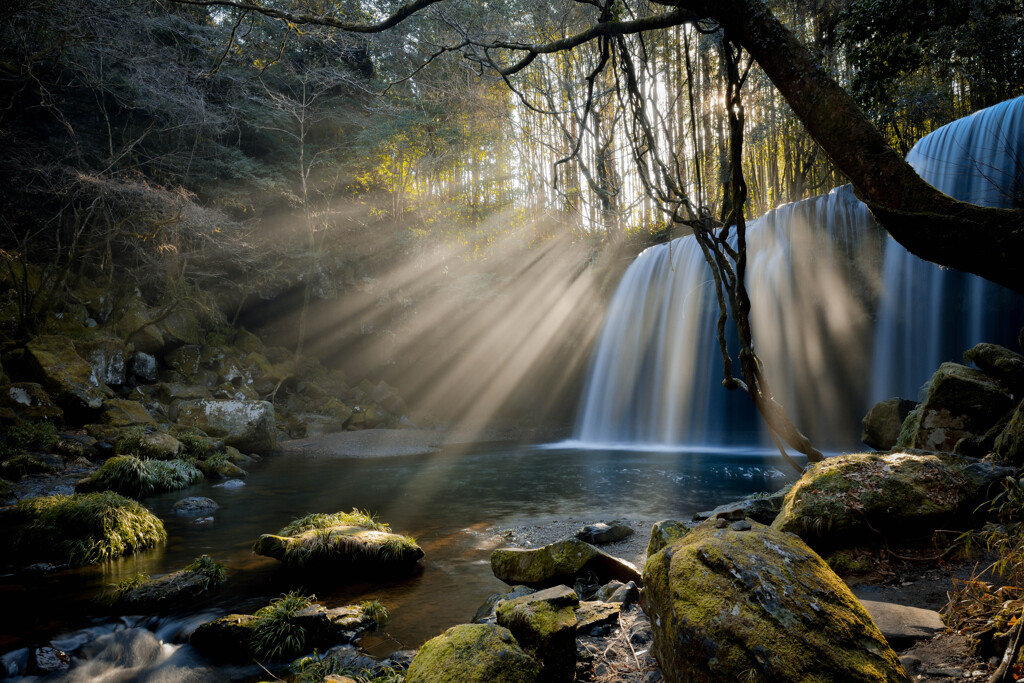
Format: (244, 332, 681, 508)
(644, 522, 906, 683)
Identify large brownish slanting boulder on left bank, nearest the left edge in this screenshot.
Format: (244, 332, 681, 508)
(25, 335, 114, 414)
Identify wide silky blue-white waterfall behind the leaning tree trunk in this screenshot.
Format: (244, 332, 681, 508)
(575, 97, 1024, 447)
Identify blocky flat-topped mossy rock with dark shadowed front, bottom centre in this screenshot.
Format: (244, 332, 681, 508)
(497, 586, 580, 681)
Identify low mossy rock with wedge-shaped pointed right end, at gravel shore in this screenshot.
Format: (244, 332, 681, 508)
(490, 539, 642, 588)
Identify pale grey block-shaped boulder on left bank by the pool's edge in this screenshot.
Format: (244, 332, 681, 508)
(172, 398, 278, 454)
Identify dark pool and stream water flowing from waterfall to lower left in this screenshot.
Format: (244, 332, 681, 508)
(0, 443, 794, 681)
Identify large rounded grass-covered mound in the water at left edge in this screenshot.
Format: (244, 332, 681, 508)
(12, 492, 167, 565)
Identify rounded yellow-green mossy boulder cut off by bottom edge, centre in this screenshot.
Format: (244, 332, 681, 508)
(406, 624, 541, 683)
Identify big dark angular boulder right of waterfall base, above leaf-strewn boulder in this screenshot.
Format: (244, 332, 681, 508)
(897, 362, 1014, 453)
